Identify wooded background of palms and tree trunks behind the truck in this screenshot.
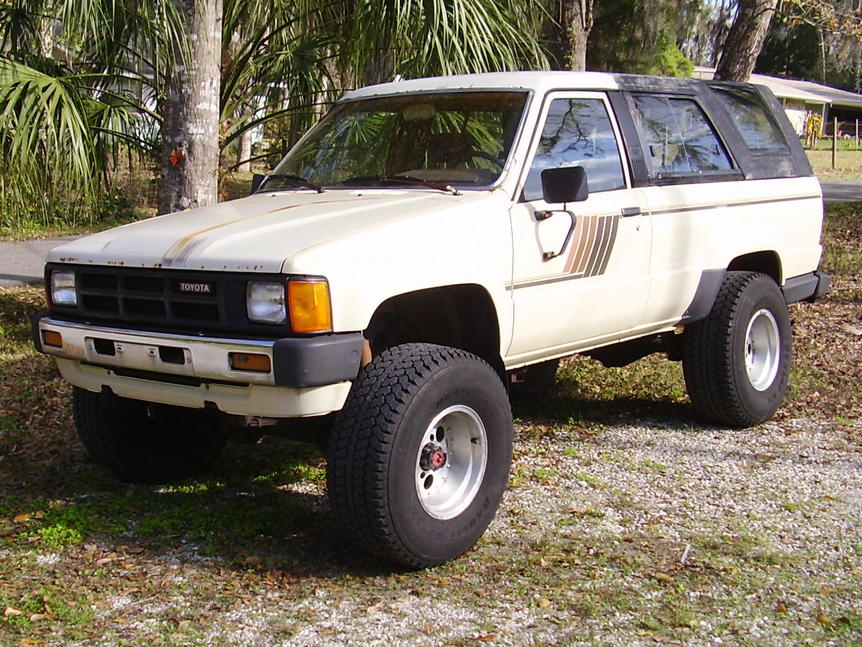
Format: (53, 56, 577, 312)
(0, 0, 862, 229)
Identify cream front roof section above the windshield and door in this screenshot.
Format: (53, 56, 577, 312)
(342, 72, 619, 99)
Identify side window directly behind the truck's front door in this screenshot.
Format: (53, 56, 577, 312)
(632, 94, 732, 179)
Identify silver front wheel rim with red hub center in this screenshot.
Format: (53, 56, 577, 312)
(415, 405, 488, 519)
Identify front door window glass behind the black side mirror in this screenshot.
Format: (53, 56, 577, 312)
(524, 99, 625, 200)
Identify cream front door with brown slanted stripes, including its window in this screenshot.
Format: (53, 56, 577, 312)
(508, 92, 651, 363)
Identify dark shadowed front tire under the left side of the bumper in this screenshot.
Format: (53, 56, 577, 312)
(73, 387, 229, 483)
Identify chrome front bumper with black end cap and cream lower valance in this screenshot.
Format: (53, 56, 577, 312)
(33, 315, 363, 417)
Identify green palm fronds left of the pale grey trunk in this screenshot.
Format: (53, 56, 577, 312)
(0, 0, 183, 224)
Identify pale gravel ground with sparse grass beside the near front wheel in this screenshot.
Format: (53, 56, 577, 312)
(58, 419, 862, 647)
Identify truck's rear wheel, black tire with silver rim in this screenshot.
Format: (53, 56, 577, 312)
(683, 272, 793, 428)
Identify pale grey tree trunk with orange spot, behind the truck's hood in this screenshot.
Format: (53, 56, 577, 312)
(159, 0, 222, 213)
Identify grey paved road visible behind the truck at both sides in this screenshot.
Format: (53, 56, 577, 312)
(0, 178, 862, 288)
